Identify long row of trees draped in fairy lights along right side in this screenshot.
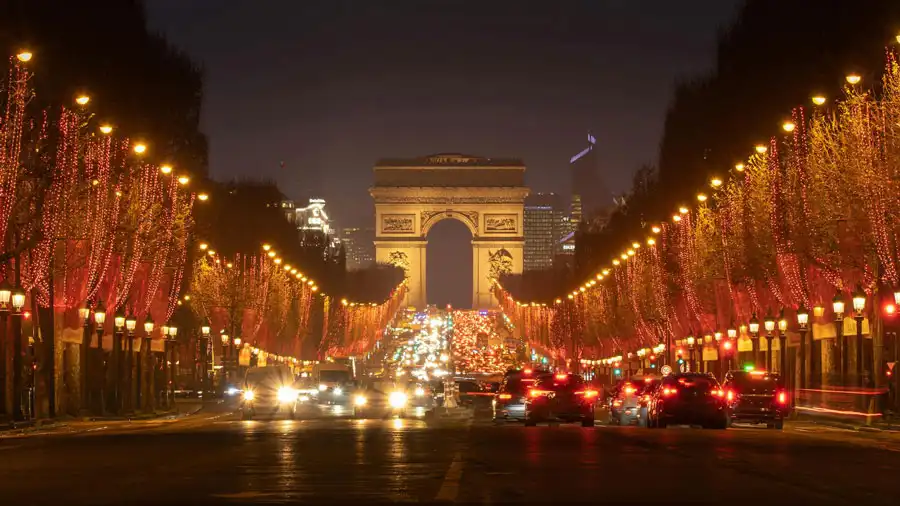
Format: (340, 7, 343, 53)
(494, 31, 900, 364)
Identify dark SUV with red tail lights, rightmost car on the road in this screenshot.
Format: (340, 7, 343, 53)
(722, 370, 790, 430)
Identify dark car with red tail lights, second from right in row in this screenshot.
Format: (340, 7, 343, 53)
(648, 372, 728, 429)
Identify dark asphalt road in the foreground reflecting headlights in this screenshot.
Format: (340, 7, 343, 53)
(0, 406, 900, 505)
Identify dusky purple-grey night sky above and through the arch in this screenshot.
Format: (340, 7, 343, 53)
(146, 0, 738, 308)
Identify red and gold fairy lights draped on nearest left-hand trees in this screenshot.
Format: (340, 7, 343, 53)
(0, 50, 208, 332)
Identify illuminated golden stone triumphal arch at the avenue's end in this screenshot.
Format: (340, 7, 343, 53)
(369, 153, 528, 309)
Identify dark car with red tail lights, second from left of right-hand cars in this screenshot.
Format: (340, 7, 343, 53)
(525, 373, 600, 427)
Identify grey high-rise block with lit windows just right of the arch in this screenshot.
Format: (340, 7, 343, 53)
(523, 193, 564, 271)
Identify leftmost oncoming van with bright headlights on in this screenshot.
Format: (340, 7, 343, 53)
(240, 366, 301, 420)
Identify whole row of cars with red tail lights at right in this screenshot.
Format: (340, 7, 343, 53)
(491, 368, 790, 430)
